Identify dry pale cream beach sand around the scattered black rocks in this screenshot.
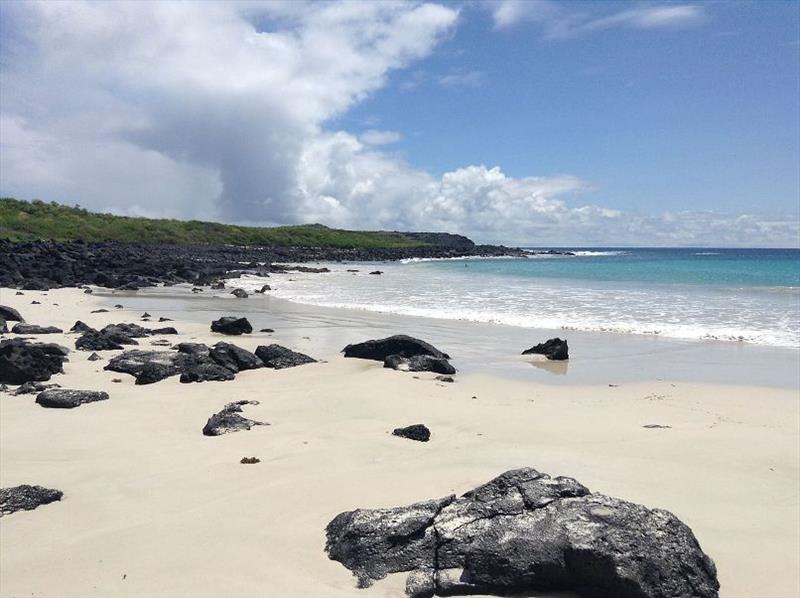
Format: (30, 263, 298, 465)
(0, 289, 800, 598)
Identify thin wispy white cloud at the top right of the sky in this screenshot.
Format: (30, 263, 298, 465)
(488, 0, 706, 38)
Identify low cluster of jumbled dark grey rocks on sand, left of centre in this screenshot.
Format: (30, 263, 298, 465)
(105, 342, 316, 384)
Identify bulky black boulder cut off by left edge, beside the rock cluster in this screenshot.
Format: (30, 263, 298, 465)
(0, 339, 68, 384)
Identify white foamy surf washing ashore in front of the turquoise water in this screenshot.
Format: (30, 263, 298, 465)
(227, 260, 800, 348)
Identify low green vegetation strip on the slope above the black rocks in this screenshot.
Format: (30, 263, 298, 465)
(0, 198, 427, 249)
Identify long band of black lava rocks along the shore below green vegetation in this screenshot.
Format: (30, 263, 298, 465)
(0, 241, 525, 290)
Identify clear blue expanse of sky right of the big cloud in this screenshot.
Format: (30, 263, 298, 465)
(341, 2, 800, 218)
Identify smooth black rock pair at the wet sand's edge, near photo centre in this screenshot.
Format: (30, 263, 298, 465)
(342, 334, 456, 375)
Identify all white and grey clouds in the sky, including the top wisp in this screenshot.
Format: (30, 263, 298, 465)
(0, 0, 800, 245)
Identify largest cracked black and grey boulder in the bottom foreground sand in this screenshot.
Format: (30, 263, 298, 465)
(326, 468, 719, 598)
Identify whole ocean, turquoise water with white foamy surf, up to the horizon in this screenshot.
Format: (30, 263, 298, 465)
(231, 247, 800, 348)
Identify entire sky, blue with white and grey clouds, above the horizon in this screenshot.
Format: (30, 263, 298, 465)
(0, 0, 800, 247)
